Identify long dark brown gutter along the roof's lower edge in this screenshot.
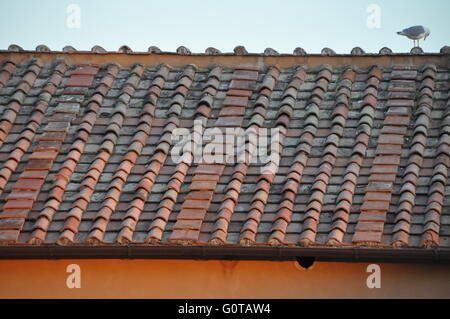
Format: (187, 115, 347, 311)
(0, 245, 450, 264)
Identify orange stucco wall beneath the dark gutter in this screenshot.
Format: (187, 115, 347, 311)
(0, 260, 450, 298)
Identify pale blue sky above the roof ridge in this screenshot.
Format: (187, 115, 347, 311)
(0, 0, 450, 53)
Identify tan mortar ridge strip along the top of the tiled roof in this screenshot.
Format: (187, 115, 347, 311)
(0, 50, 450, 68)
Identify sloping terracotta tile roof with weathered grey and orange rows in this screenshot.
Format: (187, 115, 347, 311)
(0, 48, 450, 260)
